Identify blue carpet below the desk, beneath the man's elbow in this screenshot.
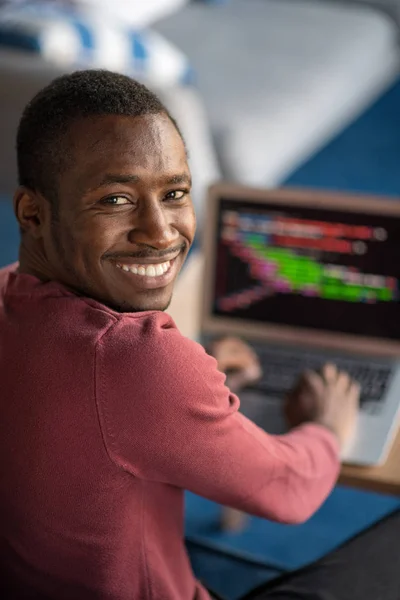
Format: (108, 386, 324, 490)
(186, 486, 400, 600)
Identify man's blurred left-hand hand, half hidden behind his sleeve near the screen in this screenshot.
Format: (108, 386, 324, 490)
(209, 337, 261, 392)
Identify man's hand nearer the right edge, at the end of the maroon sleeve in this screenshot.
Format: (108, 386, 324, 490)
(285, 365, 360, 447)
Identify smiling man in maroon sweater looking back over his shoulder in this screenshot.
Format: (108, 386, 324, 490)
(0, 71, 400, 600)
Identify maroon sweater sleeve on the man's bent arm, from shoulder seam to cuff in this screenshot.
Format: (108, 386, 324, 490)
(96, 313, 339, 523)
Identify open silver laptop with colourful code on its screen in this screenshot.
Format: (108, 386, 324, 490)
(201, 183, 400, 465)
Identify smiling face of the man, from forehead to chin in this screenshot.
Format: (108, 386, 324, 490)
(43, 114, 196, 312)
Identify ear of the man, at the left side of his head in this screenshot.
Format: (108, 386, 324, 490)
(13, 187, 49, 239)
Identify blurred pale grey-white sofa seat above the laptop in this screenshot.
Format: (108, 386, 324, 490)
(157, 0, 400, 186)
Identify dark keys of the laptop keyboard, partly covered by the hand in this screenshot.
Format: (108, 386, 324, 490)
(245, 345, 392, 413)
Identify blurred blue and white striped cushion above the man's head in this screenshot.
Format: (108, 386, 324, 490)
(0, 4, 192, 85)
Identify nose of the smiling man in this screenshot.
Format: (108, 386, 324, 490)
(129, 200, 179, 250)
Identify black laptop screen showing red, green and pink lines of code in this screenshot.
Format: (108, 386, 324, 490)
(212, 198, 400, 339)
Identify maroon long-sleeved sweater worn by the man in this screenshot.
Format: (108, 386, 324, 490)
(0, 267, 339, 600)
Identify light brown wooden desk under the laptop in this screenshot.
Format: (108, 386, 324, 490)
(168, 255, 400, 494)
